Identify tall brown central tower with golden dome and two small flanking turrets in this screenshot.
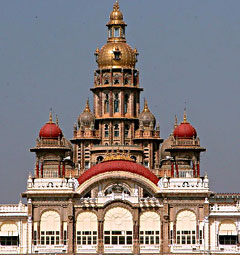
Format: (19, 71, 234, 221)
(71, 2, 162, 174)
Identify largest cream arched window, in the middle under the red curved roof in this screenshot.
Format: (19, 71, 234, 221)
(104, 207, 133, 246)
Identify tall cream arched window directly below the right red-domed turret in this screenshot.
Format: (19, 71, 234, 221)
(176, 210, 196, 244)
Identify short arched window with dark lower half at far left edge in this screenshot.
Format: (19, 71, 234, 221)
(0, 221, 19, 246)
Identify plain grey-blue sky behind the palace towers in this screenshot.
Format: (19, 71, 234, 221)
(0, 0, 240, 203)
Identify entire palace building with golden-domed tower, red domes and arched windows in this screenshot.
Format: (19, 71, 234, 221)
(0, 2, 240, 255)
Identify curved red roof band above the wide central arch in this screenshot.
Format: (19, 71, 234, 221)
(78, 160, 158, 185)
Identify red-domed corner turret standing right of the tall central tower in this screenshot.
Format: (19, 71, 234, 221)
(161, 111, 206, 178)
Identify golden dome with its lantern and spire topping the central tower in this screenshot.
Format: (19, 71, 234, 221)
(95, 2, 138, 69)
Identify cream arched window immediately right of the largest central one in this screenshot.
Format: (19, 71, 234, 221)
(140, 212, 160, 245)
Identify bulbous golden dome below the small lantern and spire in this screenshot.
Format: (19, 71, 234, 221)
(97, 42, 138, 68)
